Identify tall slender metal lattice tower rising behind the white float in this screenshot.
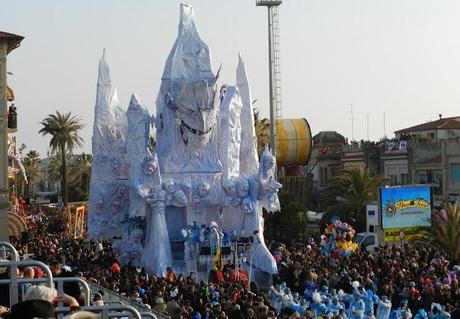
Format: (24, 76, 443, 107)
(256, 0, 282, 157)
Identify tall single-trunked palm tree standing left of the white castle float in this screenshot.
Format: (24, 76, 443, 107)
(39, 111, 84, 206)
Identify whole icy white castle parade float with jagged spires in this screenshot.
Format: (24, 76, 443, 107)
(88, 5, 281, 274)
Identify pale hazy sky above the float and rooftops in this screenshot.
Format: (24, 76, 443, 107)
(0, 0, 460, 155)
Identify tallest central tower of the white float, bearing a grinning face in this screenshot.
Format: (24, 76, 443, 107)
(156, 4, 222, 174)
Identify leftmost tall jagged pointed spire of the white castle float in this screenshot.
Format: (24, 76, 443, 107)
(88, 50, 129, 239)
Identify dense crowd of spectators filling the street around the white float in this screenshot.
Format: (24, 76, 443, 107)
(2, 208, 460, 319)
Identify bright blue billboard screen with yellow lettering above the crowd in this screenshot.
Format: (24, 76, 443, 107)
(380, 185, 433, 229)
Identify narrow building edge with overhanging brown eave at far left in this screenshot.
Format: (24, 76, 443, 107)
(0, 31, 24, 241)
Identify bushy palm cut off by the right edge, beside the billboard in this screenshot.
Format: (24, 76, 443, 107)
(424, 203, 460, 261)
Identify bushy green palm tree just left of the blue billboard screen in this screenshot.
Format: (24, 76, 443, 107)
(327, 167, 386, 230)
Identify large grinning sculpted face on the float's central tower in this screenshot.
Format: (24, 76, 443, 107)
(166, 68, 220, 149)
